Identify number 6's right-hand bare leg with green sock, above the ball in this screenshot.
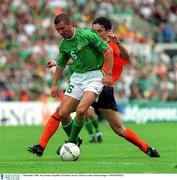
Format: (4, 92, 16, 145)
(68, 91, 97, 143)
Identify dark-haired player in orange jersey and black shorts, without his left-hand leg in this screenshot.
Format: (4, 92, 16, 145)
(92, 17, 160, 157)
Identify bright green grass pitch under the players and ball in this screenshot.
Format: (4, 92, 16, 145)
(0, 123, 177, 174)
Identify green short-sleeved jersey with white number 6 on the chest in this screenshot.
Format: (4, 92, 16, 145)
(57, 29, 109, 73)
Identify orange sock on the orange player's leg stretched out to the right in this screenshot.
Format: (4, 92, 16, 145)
(125, 128, 148, 152)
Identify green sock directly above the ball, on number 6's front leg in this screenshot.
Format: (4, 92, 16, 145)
(68, 119, 84, 143)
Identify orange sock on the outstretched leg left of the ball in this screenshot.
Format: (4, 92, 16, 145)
(39, 112, 60, 148)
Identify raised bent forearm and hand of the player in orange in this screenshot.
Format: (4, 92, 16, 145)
(109, 32, 130, 61)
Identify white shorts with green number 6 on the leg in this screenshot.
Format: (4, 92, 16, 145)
(65, 70, 104, 100)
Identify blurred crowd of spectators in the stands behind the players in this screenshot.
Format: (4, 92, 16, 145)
(0, 0, 177, 102)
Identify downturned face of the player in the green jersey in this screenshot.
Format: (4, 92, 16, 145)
(55, 21, 74, 39)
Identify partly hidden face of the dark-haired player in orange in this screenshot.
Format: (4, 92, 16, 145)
(92, 24, 109, 41)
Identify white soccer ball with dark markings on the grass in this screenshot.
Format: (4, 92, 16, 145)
(60, 143, 80, 161)
